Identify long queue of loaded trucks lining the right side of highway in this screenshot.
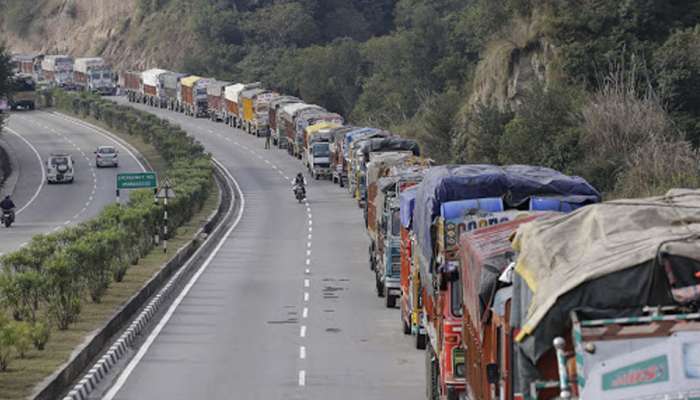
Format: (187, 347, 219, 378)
(41, 61, 700, 400)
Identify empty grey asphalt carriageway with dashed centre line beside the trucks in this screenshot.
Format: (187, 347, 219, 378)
(104, 98, 424, 400)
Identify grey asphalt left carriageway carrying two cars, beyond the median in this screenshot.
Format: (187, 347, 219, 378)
(0, 111, 146, 253)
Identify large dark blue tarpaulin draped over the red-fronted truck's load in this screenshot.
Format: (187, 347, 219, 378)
(413, 164, 600, 272)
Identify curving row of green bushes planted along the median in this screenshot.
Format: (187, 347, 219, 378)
(0, 90, 213, 338)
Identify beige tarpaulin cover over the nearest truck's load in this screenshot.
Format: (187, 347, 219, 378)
(513, 189, 700, 341)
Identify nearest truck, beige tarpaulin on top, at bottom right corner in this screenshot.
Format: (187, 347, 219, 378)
(500, 189, 700, 400)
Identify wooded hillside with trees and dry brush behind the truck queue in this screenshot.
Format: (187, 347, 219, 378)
(139, 0, 700, 197)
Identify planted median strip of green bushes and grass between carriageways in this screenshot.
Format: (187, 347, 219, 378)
(0, 91, 217, 398)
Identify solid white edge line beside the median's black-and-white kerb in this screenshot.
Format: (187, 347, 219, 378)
(103, 159, 245, 400)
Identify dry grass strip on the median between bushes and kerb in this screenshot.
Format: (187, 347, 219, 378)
(0, 121, 219, 400)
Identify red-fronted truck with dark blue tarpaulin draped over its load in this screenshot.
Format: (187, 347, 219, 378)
(413, 165, 600, 400)
